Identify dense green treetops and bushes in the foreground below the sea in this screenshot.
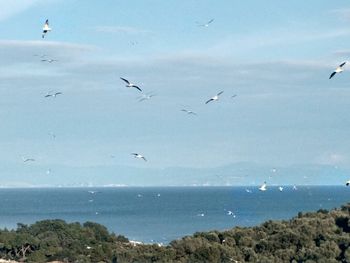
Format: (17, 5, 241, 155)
(0, 204, 350, 263)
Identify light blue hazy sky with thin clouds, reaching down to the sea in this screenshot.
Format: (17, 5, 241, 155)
(0, 0, 350, 187)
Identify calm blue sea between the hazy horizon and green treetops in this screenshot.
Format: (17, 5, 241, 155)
(0, 186, 350, 243)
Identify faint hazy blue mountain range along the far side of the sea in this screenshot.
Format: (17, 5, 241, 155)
(0, 162, 350, 187)
